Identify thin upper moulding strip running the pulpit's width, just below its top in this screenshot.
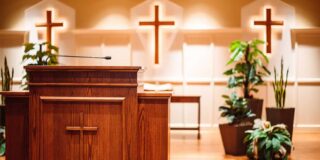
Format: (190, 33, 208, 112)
(29, 83, 138, 87)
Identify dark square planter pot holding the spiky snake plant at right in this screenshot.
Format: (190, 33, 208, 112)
(266, 108, 295, 154)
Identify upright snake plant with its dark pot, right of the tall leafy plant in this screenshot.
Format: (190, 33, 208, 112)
(266, 58, 295, 138)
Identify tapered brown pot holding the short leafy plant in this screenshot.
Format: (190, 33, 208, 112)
(219, 124, 252, 156)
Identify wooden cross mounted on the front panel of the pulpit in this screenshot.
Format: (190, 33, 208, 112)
(66, 112, 98, 160)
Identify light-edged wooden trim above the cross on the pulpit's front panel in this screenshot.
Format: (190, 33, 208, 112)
(40, 96, 125, 102)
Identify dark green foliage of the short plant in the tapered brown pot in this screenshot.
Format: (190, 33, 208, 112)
(219, 93, 255, 124)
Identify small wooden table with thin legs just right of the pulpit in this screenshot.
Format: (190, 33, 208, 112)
(170, 95, 201, 139)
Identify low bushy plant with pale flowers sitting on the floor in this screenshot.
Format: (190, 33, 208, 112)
(244, 119, 292, 160)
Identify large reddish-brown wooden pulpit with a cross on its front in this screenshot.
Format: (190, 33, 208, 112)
(2, 66, 171, 160)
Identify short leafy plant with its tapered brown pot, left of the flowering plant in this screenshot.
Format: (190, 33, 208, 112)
(219, 93, 255, 155)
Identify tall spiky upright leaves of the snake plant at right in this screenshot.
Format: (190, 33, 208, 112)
(272, 58, 289, 108)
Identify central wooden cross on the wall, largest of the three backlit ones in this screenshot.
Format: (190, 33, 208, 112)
(139, 5, 175, 64)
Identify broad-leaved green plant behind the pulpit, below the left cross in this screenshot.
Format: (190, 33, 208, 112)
(22, 42, 59, 90)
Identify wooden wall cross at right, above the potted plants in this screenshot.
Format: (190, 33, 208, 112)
(254, 8, 283, 53)
